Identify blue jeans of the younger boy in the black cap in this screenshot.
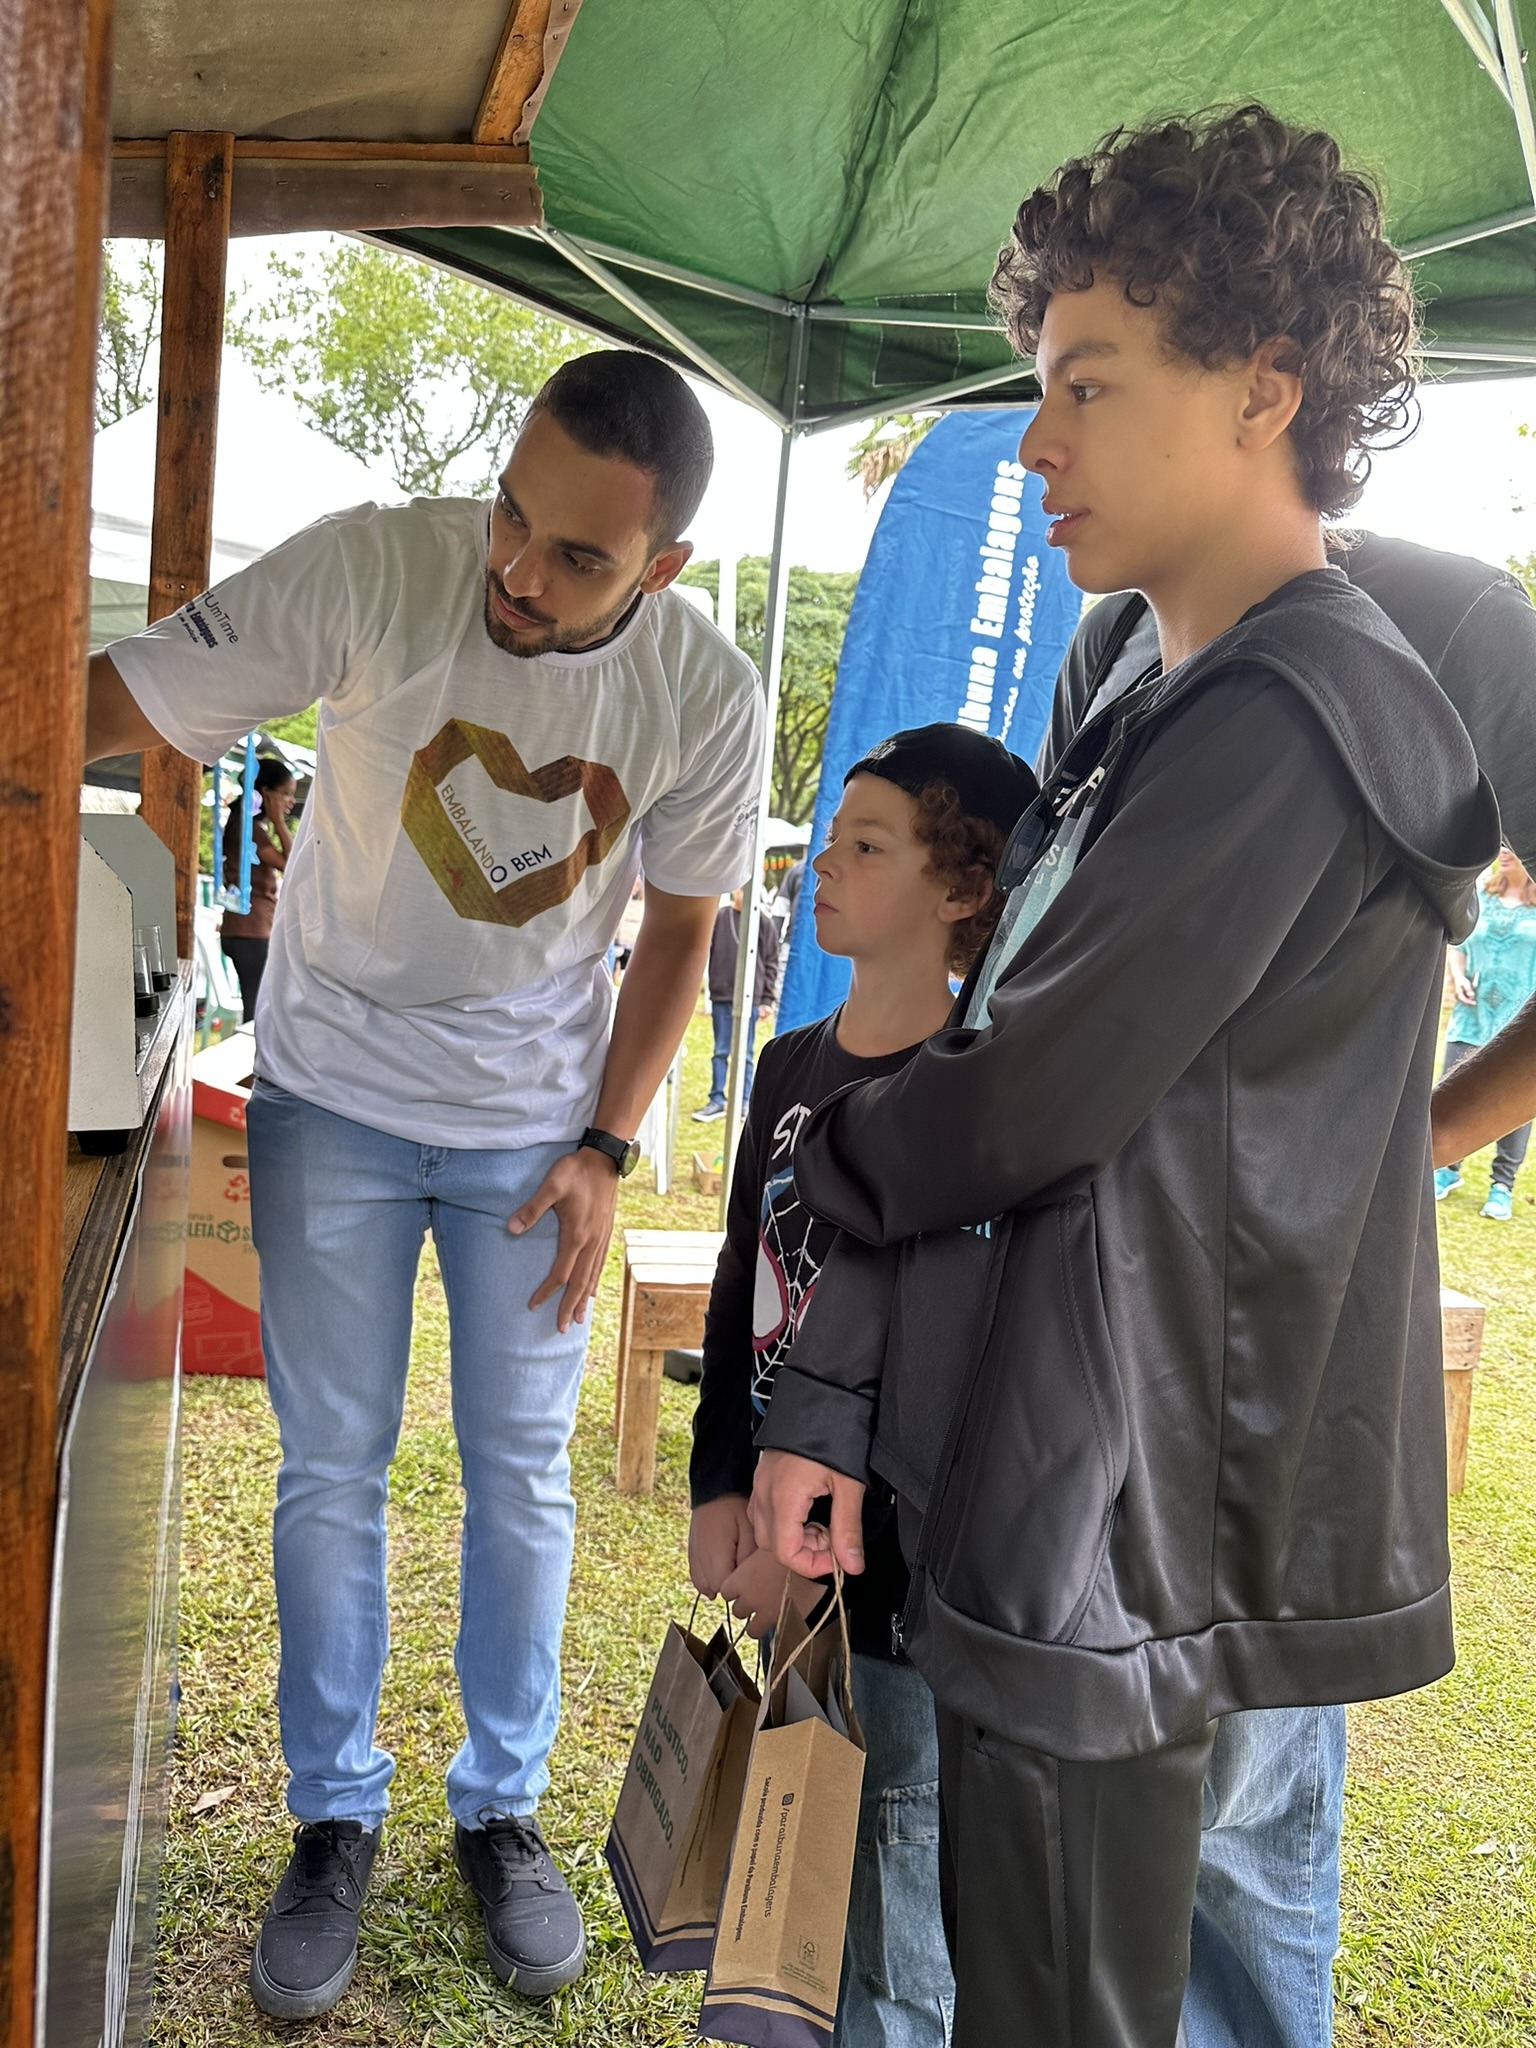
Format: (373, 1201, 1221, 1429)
(834, 1655, 954, 2048)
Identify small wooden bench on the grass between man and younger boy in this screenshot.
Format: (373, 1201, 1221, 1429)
(614, 1231, 725, 1493)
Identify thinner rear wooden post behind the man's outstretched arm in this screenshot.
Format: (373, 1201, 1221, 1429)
(139, 131, 236, 961)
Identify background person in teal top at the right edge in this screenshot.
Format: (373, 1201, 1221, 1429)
(1436, 846, 1536, 1223)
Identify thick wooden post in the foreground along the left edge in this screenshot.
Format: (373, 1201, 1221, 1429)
(0, 0, 111, 2048)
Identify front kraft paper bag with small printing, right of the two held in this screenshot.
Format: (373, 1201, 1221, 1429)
(698, 1583, 864, 2048)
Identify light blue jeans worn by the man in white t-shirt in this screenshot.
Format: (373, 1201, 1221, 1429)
(248, 1081, 586, 1827)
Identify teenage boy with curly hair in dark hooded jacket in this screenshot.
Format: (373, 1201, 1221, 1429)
(754, 106, 1497, 2048)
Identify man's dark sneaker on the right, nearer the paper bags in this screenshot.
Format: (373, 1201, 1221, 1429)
(453, 1817, 586, 1999)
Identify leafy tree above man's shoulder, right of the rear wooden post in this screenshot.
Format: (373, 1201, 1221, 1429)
(229, 244, 590, 498)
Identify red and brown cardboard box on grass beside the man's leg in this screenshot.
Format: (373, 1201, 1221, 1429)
(182, 1026, 266, 1378)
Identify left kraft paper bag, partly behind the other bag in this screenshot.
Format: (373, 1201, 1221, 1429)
(606, 1602, 758, 1970)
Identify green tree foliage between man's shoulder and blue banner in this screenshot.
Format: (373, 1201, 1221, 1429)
(682, 555, 858, 825)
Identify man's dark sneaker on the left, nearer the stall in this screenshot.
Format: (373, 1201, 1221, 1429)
(250, 1821, 383, 2019)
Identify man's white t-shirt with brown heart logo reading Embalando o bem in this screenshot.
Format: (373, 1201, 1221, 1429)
(106, 500, 764, 1147)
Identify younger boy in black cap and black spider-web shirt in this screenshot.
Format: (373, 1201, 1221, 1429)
(688, 725, 1036, 2048)
